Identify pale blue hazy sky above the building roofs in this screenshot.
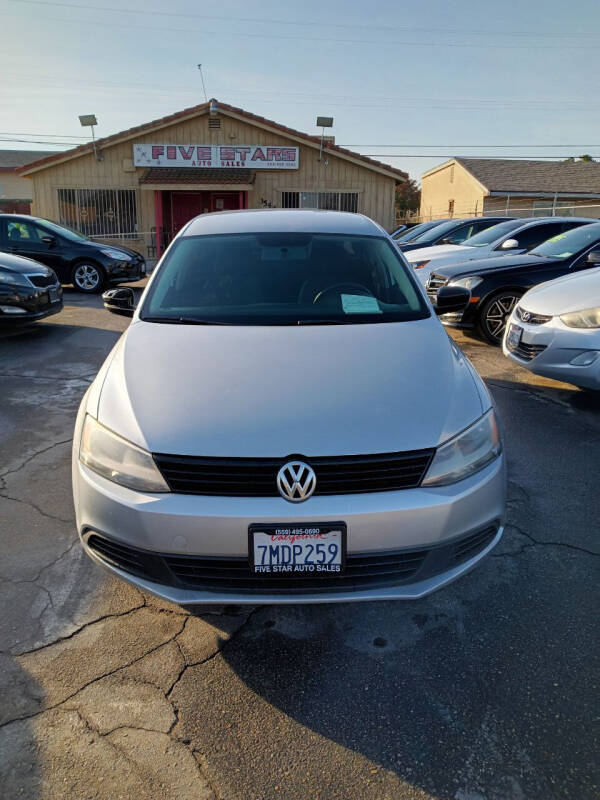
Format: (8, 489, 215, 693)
(0, 0, 600, 179)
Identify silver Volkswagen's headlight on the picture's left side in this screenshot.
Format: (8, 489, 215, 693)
(79, 414, 169, 492)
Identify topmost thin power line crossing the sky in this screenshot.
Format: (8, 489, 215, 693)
(10, 0, 598, 39)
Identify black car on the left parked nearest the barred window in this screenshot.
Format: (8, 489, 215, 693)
(0, 214, 146, 293)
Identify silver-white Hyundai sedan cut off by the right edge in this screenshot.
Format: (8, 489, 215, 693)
(502, 268, 600, 390)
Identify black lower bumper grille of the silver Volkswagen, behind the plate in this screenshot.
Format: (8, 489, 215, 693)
(86, 525, 498, 593)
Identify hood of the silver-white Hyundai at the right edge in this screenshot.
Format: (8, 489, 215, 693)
(519, 268, 600, 316)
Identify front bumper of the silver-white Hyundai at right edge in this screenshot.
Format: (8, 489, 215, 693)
(502, 314, 600, 390)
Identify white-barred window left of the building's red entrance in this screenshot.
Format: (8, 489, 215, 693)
(58, 189, 138, 239)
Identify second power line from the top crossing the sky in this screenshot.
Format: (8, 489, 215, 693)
(3, 11, 598, 51)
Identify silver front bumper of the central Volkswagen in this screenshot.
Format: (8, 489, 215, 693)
(73, 455, 506, 605)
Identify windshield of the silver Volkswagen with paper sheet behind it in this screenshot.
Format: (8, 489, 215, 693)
(140, 233, 429, 325)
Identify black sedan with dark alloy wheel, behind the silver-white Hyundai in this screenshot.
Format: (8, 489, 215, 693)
(426, 222, 600, 345)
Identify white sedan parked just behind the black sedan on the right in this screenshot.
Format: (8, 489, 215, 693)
(406, 217, 594, 284)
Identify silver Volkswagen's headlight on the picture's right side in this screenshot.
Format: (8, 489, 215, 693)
(421, 408, 502, 486)
